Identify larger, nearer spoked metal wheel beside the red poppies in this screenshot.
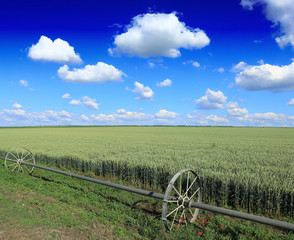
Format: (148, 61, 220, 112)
(162, 169, 202, 231)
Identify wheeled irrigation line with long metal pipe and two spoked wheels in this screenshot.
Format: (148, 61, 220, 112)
(0, 147, 294, 231)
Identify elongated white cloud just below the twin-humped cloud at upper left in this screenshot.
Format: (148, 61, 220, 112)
(58, 62, 125, 83)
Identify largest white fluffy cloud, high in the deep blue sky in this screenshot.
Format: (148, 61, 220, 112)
(108, 13, 210, 58)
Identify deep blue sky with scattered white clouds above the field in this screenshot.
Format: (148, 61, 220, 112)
(0, 0, 294, 127)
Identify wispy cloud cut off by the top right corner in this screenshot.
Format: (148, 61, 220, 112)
(241, 0, 294, 49)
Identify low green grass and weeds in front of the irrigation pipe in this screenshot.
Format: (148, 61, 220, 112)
(0, 162, 294, 240)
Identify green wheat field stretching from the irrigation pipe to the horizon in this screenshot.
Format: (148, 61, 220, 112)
(0, 127, 294, 218)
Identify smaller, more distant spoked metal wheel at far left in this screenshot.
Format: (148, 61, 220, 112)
(5, 147, 35, 173)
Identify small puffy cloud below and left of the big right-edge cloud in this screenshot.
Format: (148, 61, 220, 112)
(195, 89, 227, 109)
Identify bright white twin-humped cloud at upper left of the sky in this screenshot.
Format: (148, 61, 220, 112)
(28, 36, 82, 64)
